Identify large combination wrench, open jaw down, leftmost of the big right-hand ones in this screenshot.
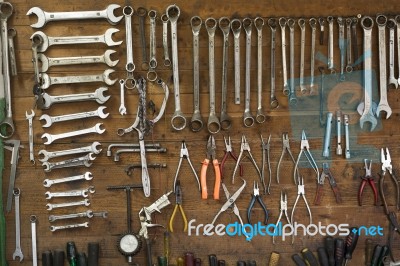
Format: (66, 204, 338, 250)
(360, 16, 378, 131)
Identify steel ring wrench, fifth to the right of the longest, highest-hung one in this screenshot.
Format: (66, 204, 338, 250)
(243, 18, 254, 127)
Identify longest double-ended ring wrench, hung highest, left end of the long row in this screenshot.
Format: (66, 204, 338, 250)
(166, 5, 186, 130)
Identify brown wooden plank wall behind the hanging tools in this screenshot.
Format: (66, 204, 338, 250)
(3, 0, 400, 265)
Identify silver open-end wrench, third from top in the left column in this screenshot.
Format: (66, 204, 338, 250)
(38, 50, 119, 72)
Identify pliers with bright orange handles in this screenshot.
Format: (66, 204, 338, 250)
(200, 135, 221, 200)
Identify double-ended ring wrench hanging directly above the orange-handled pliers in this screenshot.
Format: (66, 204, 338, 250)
(204, 18, 221, 134)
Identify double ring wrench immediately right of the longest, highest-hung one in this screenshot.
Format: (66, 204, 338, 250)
(190, 16, 203, 132)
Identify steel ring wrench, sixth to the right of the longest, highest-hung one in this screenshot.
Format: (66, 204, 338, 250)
(254, 17, 266, 123)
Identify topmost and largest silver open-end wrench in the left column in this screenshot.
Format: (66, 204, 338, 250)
(26, 4, 123, 28)
